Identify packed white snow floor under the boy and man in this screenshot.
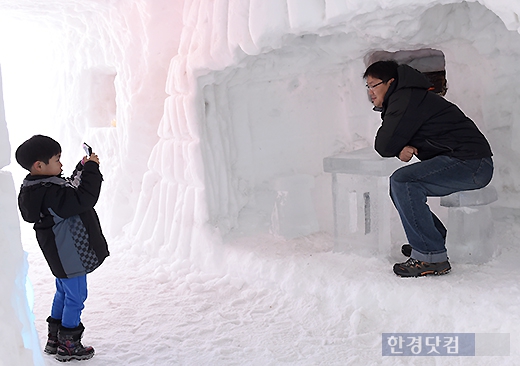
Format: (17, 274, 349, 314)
(23, 209, 520, 366)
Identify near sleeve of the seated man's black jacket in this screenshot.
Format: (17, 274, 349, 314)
(374, 88, 422, 157)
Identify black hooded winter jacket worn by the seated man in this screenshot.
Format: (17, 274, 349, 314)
(375, 65, 492, 160)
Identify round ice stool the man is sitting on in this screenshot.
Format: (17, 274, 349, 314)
(440, 186, 498, 263)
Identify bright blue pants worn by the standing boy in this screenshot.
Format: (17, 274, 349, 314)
(51, 275, 87, 328)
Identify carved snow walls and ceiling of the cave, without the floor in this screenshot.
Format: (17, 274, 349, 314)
(0, 0, 520, 365)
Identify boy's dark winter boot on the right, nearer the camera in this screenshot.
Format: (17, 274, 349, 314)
(56, 323, 94, 362)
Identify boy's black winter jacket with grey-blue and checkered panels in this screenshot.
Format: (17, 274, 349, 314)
(18, 161, 109, 278)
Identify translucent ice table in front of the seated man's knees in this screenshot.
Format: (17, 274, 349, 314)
(323, 147, 406, 255)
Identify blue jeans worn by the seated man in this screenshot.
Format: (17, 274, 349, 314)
(390, 156, 493, 263)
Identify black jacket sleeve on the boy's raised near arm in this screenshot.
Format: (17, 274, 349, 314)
(45, 162, 103, 218)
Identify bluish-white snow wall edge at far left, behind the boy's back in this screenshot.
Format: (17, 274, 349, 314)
(0, 69, 43, 365)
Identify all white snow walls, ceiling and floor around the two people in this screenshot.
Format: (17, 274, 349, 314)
(0, 0, 520, 366)
